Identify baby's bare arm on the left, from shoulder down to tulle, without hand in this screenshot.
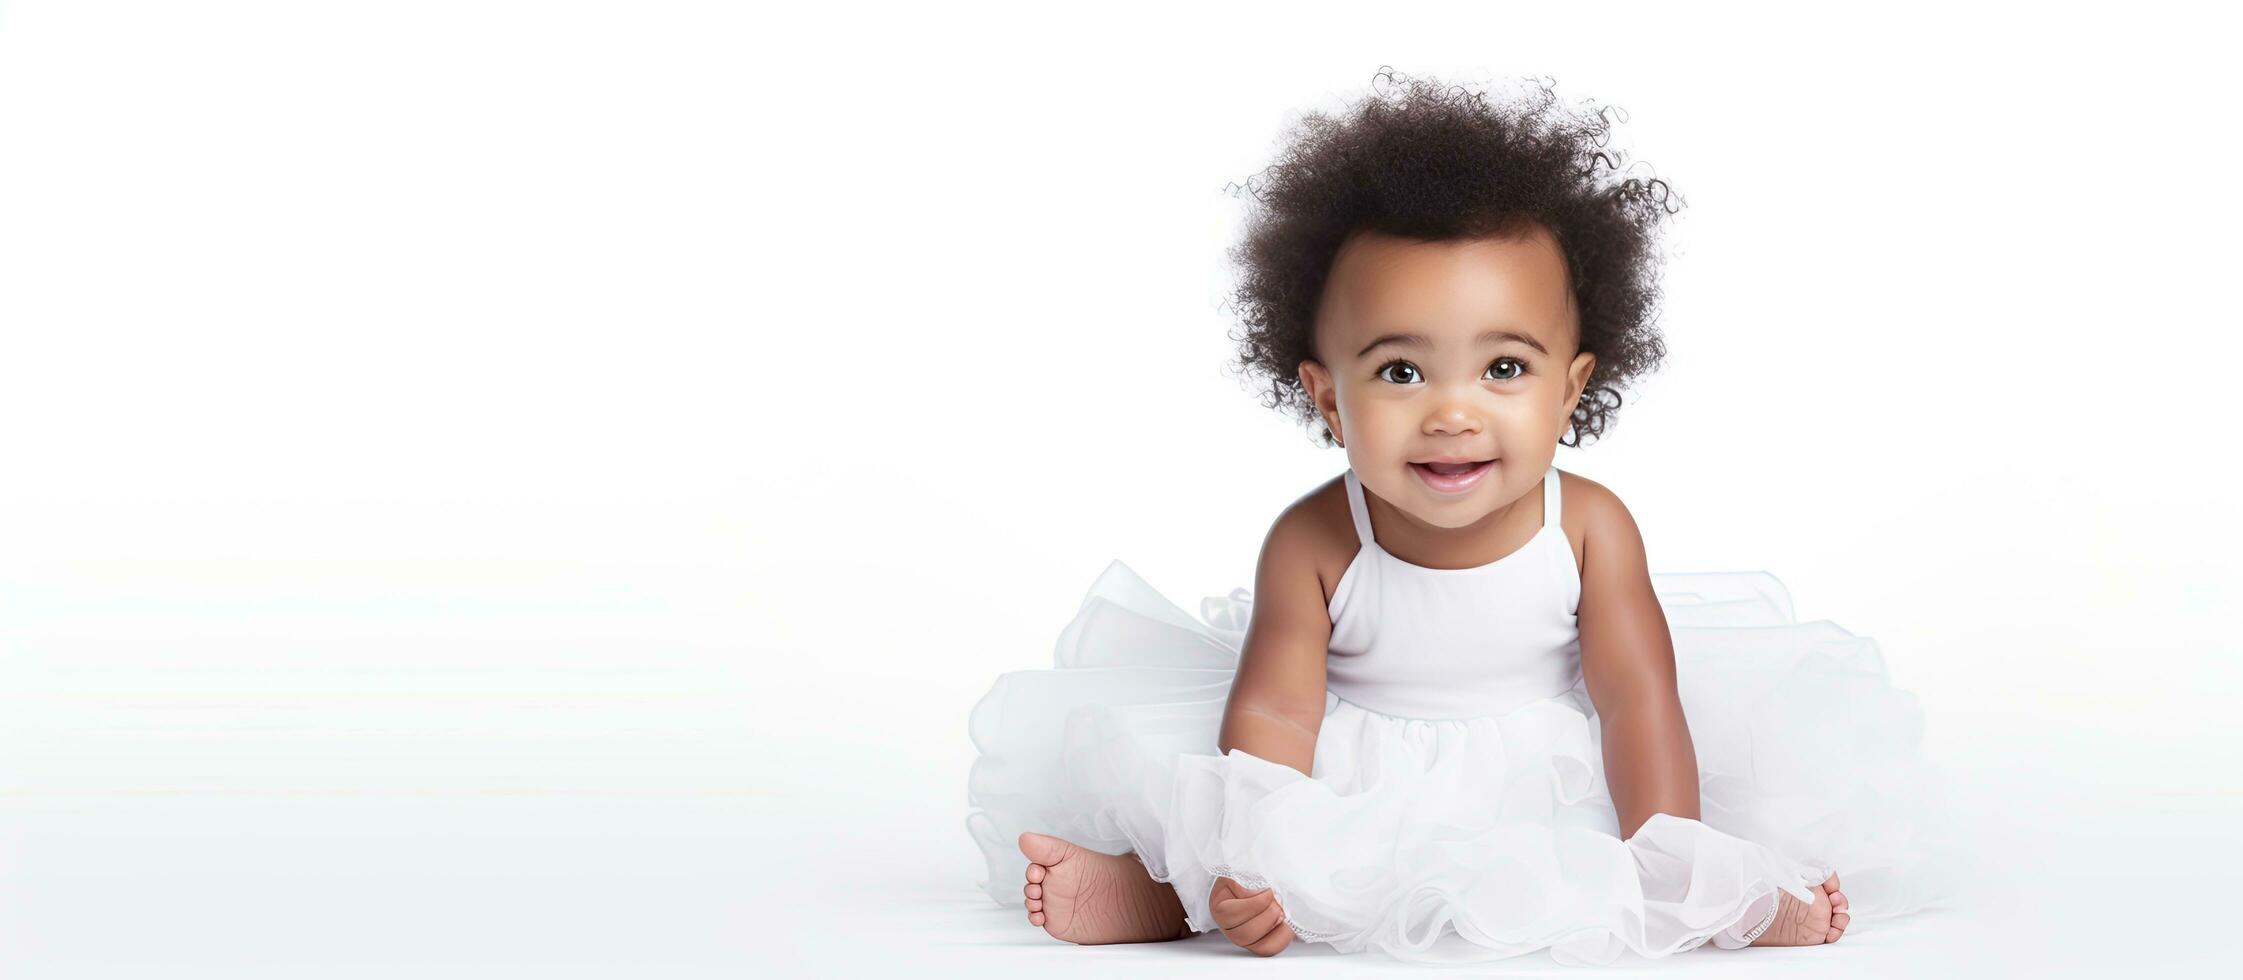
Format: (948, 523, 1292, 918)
(1216, 500, 1332, 776)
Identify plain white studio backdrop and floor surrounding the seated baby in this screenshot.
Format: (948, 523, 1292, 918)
(0, 0, 2243, 978)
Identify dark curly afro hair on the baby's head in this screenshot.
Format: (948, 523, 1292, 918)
(1229, 67, 1680, 446)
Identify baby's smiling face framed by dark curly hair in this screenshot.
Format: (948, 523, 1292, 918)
(1301, 226, 1597, 527)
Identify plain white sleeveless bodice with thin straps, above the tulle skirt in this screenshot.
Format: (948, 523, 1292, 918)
(1323, 466, 1581, 720)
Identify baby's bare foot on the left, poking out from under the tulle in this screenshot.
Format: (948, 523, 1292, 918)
(1021, 832, 1191, 946)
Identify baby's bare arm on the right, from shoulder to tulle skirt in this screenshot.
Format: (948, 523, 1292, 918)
(1561, 473, 1698, 836)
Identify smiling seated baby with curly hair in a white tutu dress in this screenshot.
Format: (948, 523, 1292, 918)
(971, 72, 1931, 962)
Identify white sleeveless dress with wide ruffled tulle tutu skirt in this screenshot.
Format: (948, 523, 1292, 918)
(967, 466, 1960, 964)
